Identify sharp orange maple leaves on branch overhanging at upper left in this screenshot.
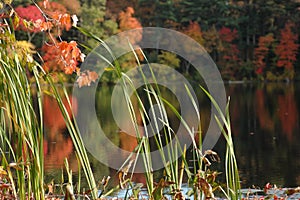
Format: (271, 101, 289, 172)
(36, 0, 80, 74)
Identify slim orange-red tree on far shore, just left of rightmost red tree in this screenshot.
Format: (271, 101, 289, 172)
(254, 34, 274, 74)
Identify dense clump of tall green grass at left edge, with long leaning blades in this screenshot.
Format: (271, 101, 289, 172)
(0, 20, 98, 199)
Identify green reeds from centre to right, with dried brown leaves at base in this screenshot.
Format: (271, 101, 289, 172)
(78, 24, 240, 199)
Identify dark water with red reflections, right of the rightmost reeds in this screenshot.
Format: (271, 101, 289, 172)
(227, 83, 300, 186)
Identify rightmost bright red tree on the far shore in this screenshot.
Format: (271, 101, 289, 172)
(275, 23, 299, 69)
